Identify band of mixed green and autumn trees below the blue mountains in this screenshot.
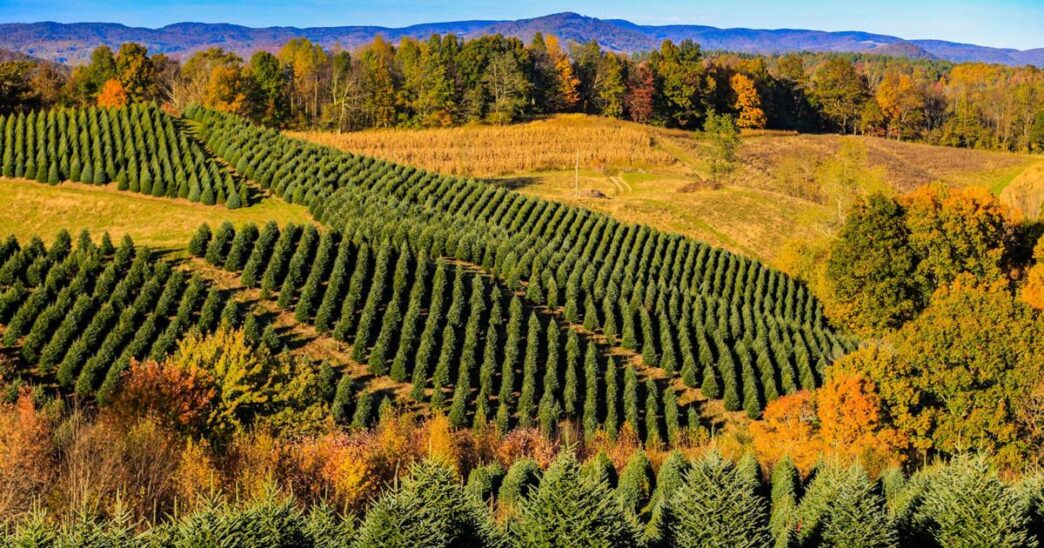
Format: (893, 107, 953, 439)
(0, 33, 1044, 151)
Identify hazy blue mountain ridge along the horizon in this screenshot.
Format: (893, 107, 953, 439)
(0, 13, 1044, 67)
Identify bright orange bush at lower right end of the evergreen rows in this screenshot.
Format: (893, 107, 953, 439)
(750, 374, 907, 474)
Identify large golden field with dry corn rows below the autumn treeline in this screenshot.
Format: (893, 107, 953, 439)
(292, 115, 1044, 264)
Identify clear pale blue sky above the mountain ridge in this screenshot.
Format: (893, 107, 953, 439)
(0, 0, 1044, 49)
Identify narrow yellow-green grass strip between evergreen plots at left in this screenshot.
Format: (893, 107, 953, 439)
(0, 177, 313, 248)
